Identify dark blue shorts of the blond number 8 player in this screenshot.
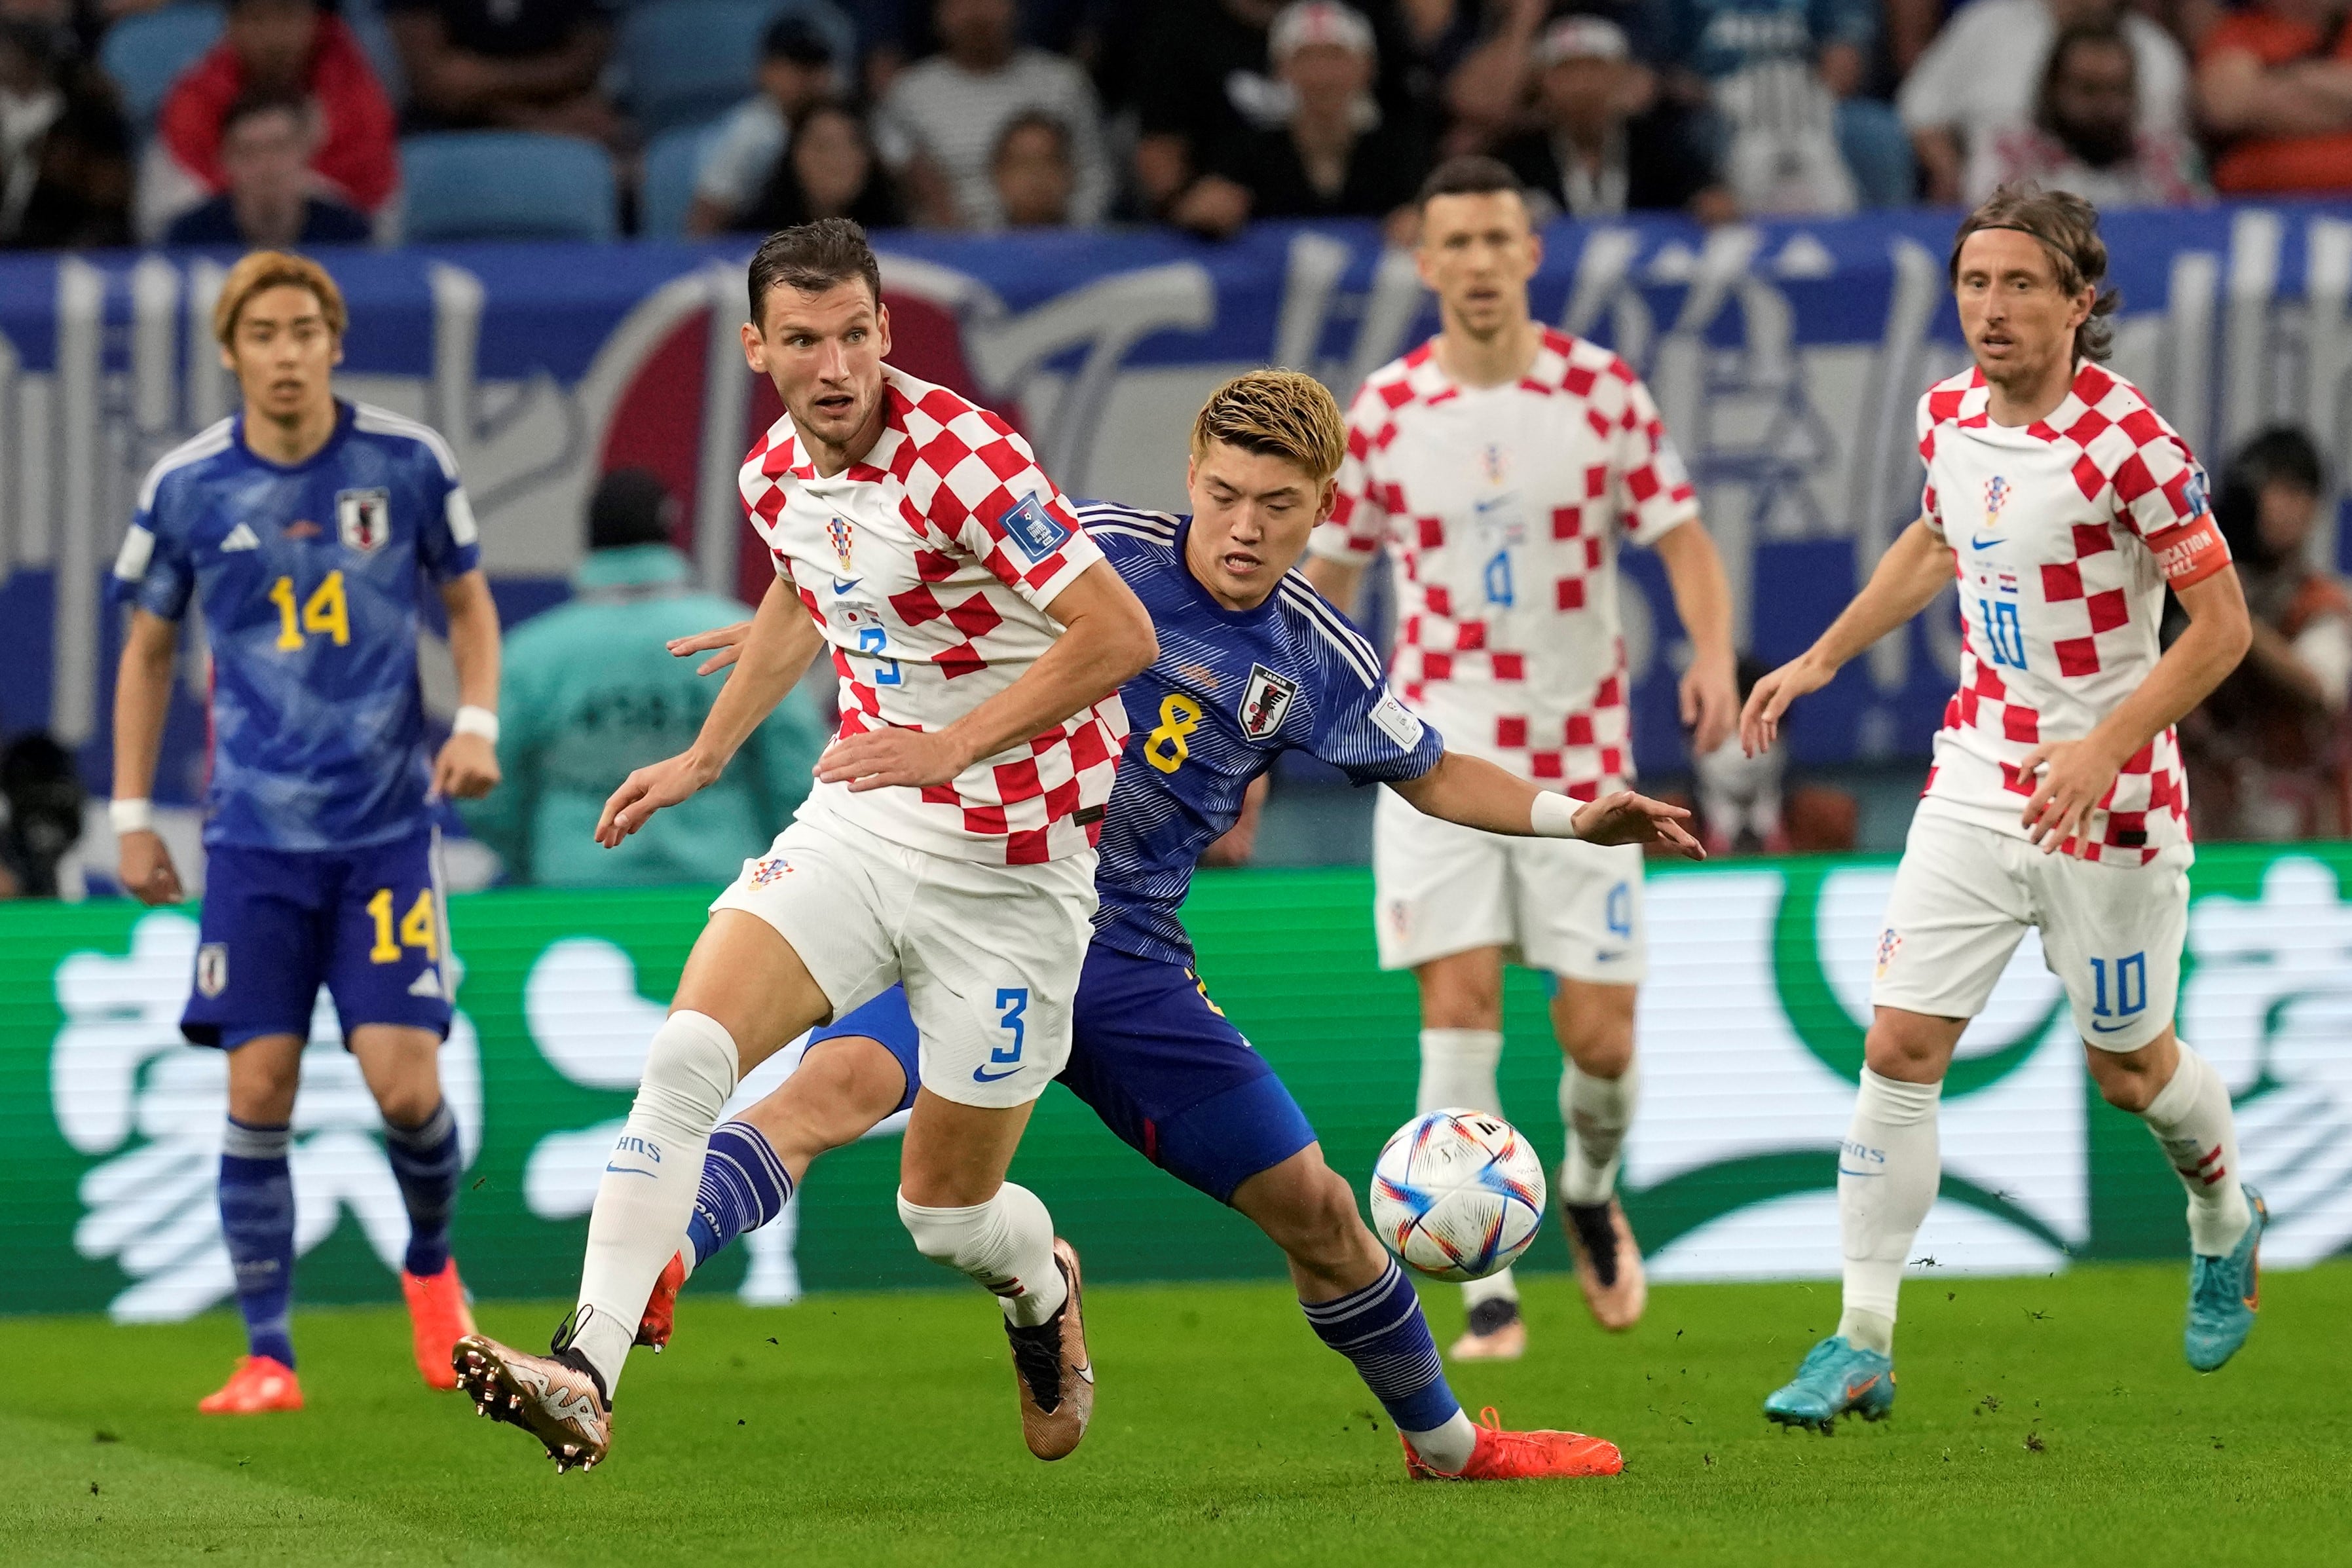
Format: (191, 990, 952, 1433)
(809, 943, 1315, 1204)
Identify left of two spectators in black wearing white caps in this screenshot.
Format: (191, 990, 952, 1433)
(1169, 0, 1430, 244)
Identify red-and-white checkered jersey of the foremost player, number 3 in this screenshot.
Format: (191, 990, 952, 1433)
(739, 367, 1127, 865)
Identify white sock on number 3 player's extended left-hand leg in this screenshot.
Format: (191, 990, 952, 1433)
(572, 1011, 741, 1396)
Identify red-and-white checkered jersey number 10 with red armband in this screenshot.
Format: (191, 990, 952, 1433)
(1919, 364, 2230, 865)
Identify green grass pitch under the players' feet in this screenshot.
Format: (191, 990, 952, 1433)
(0, 1262, 2352, 1568)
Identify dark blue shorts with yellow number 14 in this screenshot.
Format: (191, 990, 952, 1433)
(179, 830, 449, 1051)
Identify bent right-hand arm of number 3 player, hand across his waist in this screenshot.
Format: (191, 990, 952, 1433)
(818, 562, 1159, 790)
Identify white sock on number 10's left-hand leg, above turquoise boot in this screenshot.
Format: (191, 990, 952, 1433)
(1837, 1067, 1943, 1352)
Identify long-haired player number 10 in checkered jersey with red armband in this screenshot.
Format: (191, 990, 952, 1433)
(1740, 186, 2265, 1429)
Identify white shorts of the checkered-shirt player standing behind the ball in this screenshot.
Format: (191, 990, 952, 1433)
(1372, 790, 1649, 985)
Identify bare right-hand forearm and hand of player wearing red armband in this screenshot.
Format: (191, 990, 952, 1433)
(2018, 567, 2253, 853)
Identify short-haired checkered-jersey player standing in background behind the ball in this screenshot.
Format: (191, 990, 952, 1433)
(1308, 157, 1738, 1359)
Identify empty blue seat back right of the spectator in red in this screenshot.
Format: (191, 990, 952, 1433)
(400, 132, 621, 242)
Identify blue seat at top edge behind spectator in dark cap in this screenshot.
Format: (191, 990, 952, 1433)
(618, 0, 856, 134)
